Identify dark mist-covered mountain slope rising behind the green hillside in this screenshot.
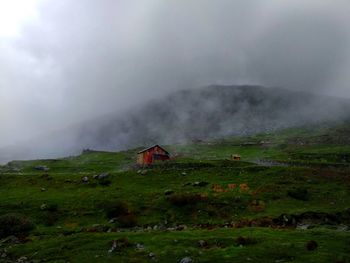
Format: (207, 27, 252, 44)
(0, 86, 350, 161)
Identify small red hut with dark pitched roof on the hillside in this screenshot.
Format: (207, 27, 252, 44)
(137, 145, 170, 165)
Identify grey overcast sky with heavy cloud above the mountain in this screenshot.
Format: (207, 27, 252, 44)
(0, 0, 350, 146)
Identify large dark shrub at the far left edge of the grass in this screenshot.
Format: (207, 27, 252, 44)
(0, 214, 34, 238)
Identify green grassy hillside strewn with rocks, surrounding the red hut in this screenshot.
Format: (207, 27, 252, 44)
(0, 123, 350, 262)
